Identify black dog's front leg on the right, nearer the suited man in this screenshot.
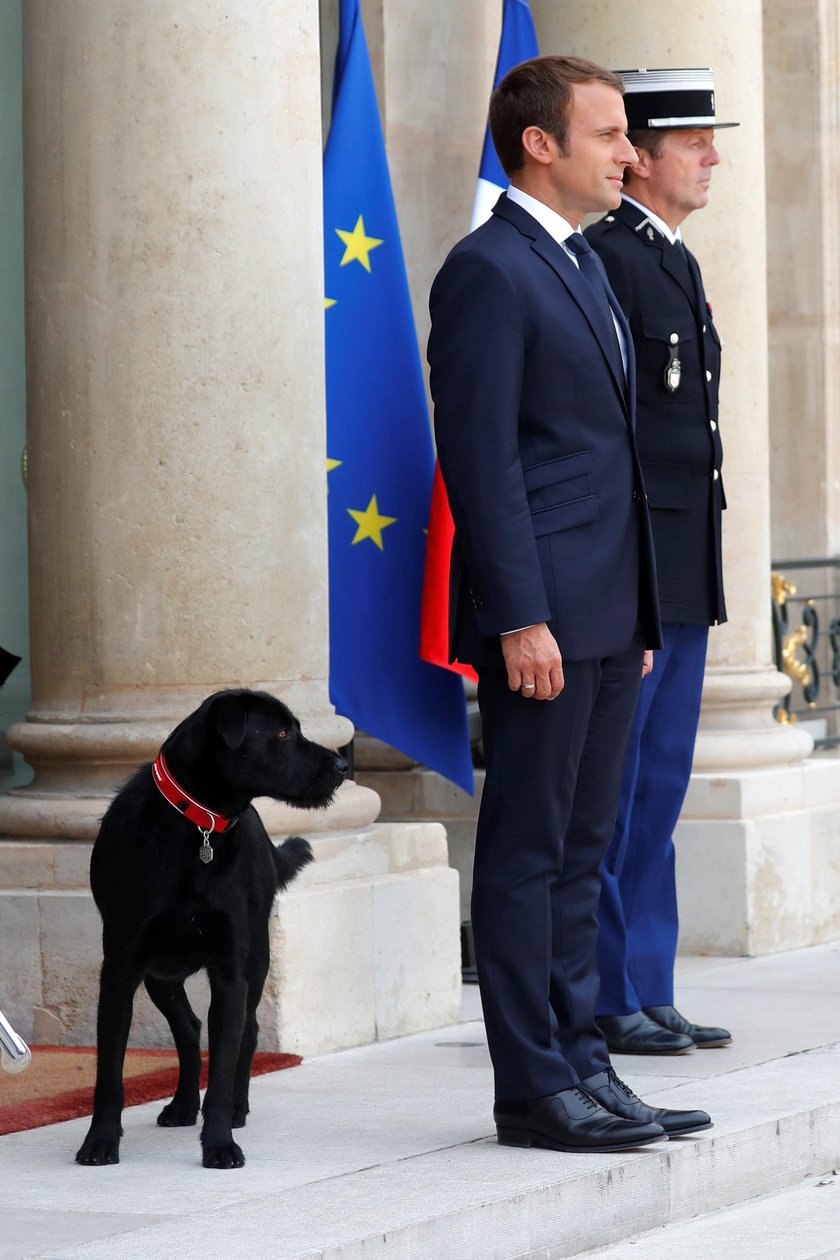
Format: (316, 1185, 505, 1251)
(201, 966, 248, 1168)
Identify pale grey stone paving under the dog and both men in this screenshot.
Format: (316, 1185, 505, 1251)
(0, 944, 840, 1260)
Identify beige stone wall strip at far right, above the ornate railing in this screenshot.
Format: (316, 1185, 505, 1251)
(763, 0, 840, 558)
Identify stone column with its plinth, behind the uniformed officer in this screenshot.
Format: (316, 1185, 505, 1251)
(531, 0, 840, 953)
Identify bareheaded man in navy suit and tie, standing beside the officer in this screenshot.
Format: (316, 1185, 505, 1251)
(428, 57, 710, 1150)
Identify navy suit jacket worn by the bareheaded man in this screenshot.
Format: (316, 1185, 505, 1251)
(428, 195, 660, 664)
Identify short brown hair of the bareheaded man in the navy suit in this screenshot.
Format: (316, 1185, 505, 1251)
(490, 57, 625, 175)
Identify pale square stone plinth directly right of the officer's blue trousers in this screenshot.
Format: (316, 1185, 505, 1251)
(674, 755, 840, 955)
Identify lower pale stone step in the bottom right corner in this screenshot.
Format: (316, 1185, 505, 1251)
(581, 1169, 840, 1260)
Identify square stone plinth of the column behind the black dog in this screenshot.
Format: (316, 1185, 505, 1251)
(0, 816, 461, 1055)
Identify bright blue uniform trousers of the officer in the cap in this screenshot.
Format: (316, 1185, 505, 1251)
(597, 622, 709, 1016)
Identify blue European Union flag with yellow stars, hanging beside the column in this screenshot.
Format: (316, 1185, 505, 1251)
(324, 0, 472, 791)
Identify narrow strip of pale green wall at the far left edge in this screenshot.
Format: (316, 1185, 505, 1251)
(0, 0, 29, 784)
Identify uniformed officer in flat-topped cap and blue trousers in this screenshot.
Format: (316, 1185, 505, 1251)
(586, 69, 737, 1055)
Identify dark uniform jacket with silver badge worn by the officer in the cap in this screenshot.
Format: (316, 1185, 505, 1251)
(586, 200, 727, 625)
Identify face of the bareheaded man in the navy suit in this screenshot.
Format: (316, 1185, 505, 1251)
(536, 79, 636, 226)
